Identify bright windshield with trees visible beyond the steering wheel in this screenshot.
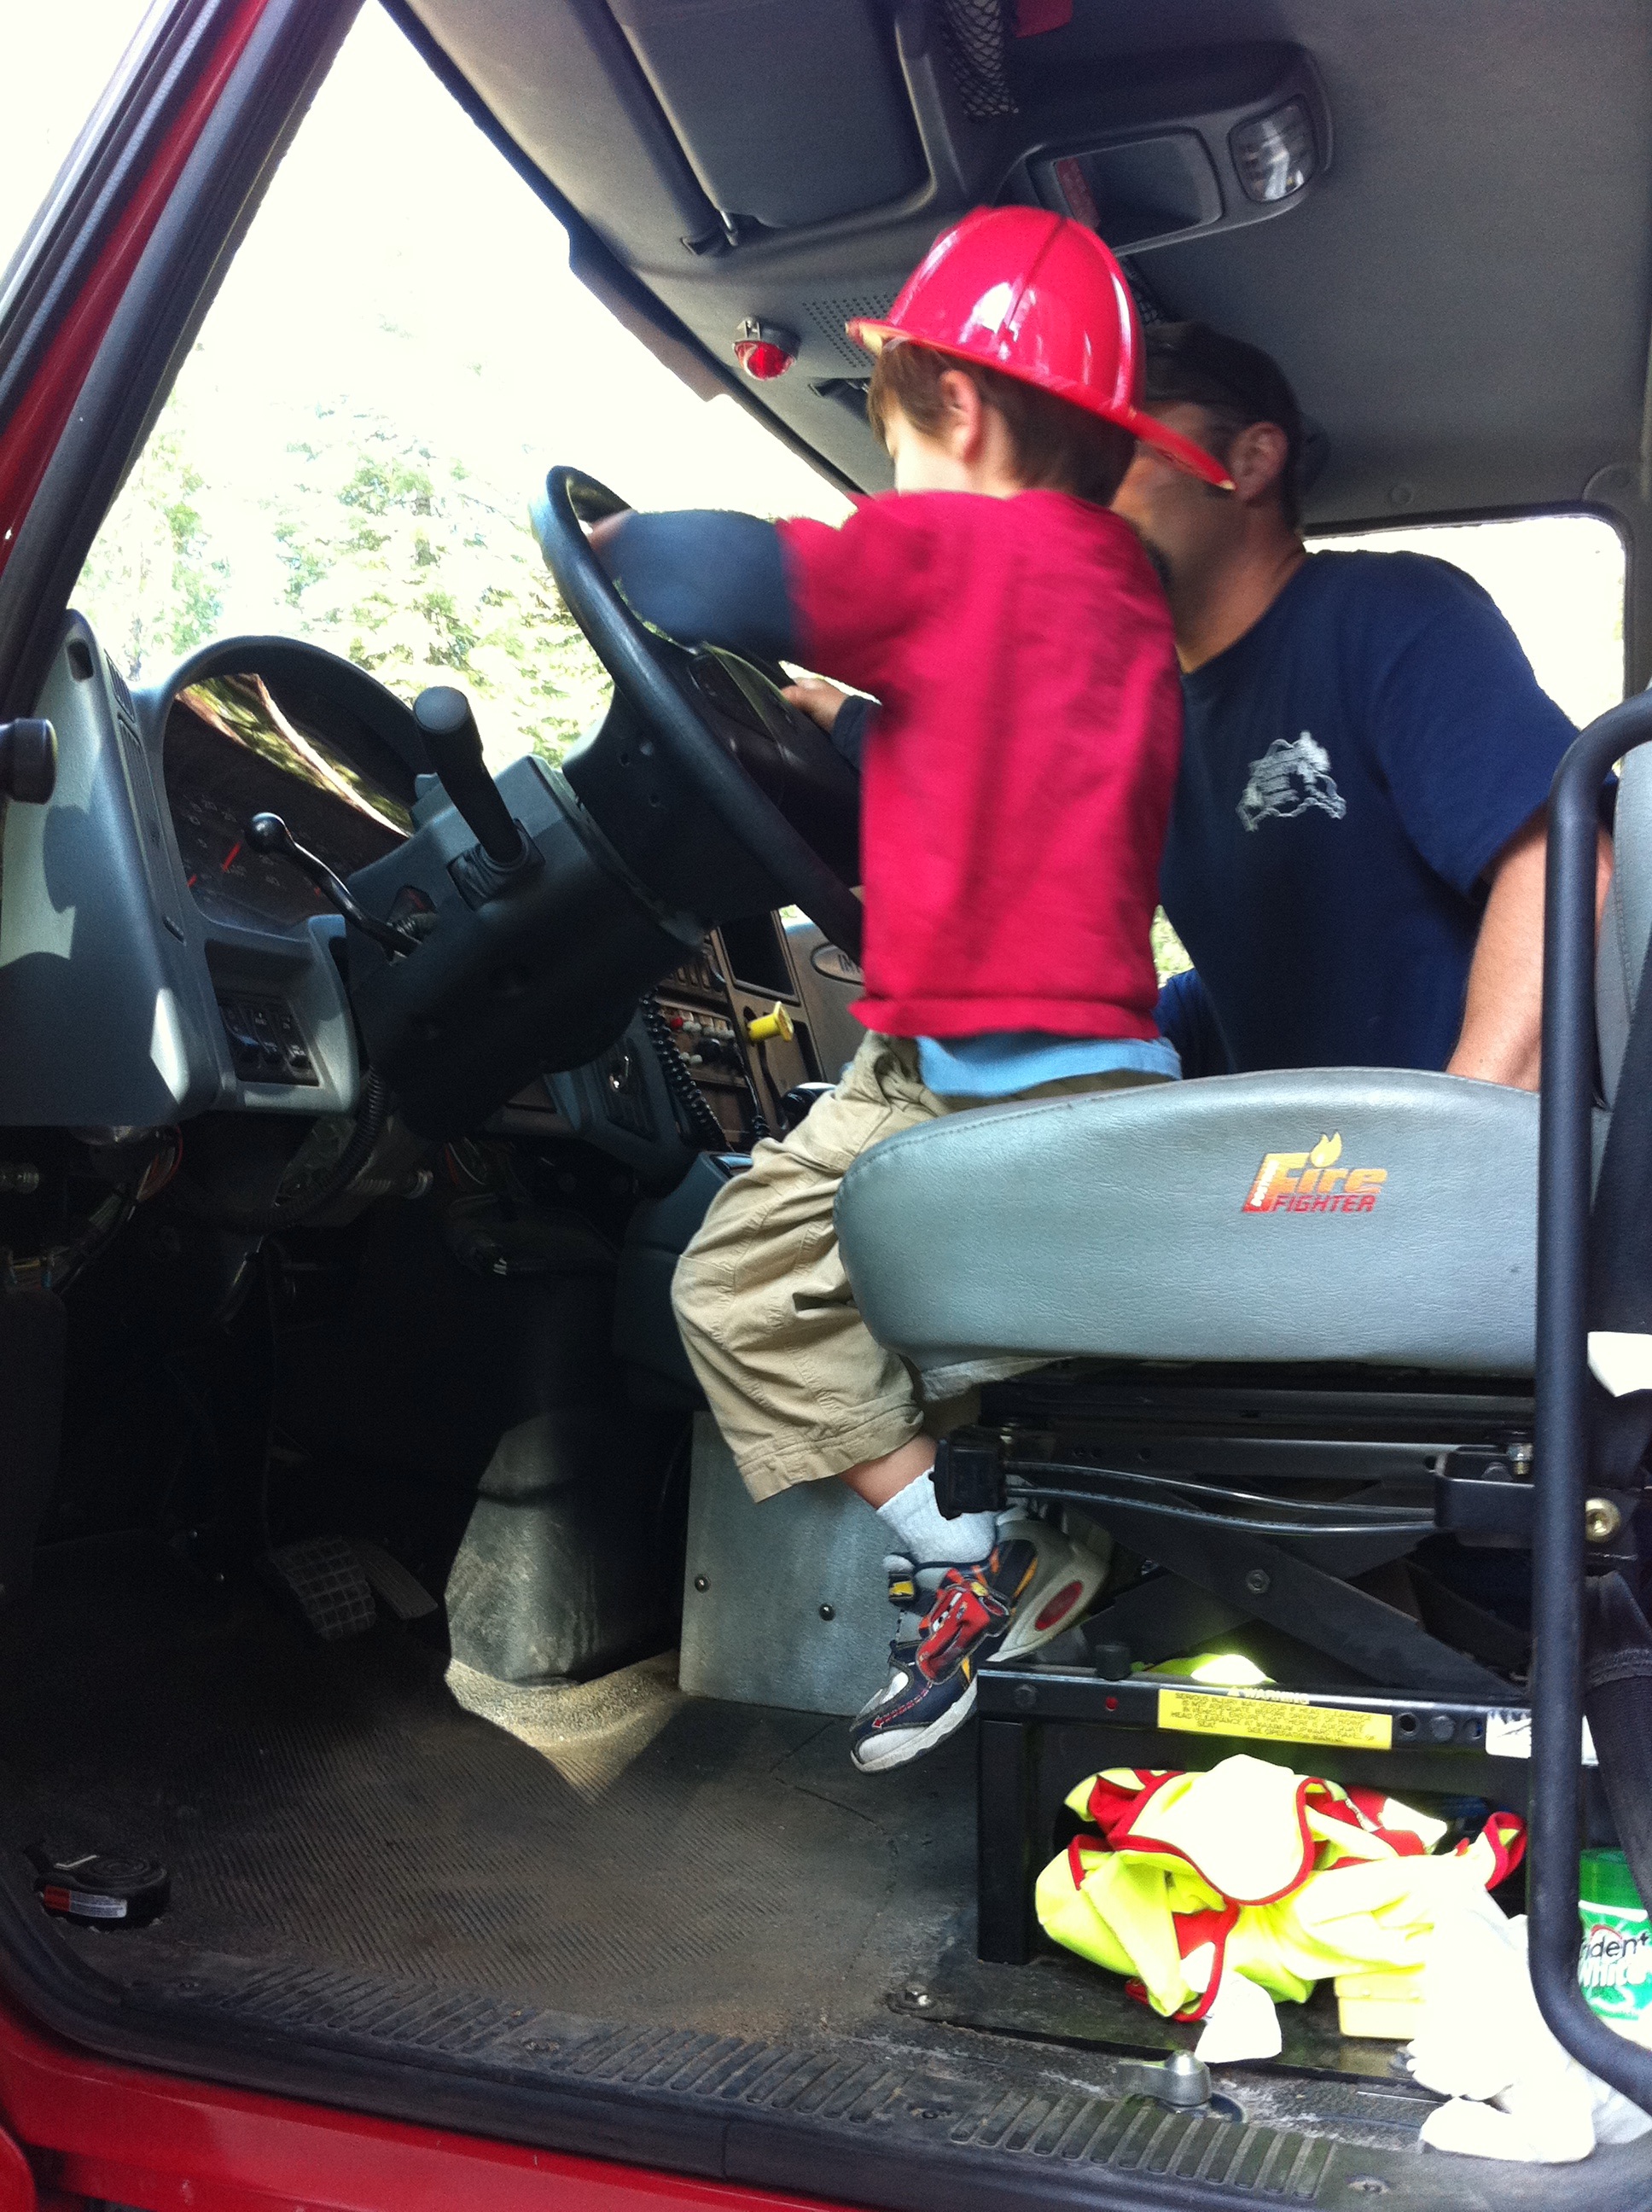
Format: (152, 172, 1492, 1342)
(75, 9, 847, 767)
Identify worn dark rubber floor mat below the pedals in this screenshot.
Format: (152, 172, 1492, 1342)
(0, 1540, 973, 2033)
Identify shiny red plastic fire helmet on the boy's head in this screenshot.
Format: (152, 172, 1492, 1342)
(847, 208, 1234, 491)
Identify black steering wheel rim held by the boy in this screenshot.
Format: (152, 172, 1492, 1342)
(533, 469, 860, 960)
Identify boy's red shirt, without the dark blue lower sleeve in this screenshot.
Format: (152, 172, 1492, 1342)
(778, 491, 1181, 1038)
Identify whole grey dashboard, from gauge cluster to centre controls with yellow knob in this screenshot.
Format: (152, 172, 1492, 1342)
(0, 615, 858, 1188)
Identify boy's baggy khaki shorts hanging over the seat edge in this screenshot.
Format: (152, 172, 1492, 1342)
(672, 1035, 1163, 1498)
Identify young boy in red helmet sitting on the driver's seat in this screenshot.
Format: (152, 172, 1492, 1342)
(595, 208, 1225, 1770)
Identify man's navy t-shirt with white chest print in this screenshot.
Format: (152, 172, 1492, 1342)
(1161, 553, 1577, 1071)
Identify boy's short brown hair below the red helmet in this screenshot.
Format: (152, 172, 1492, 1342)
(867, 339, 1137, 507)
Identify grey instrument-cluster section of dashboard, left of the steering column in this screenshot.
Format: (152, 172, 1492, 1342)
(0, 613, 429, 1128)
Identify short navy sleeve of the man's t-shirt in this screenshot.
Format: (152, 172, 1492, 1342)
(1371, 553, 1577, 896)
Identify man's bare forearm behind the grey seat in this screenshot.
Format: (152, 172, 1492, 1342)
(1446, 810, 1612, 1091)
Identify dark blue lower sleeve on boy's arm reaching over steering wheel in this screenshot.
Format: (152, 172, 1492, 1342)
(602, 509, 796, 661)
